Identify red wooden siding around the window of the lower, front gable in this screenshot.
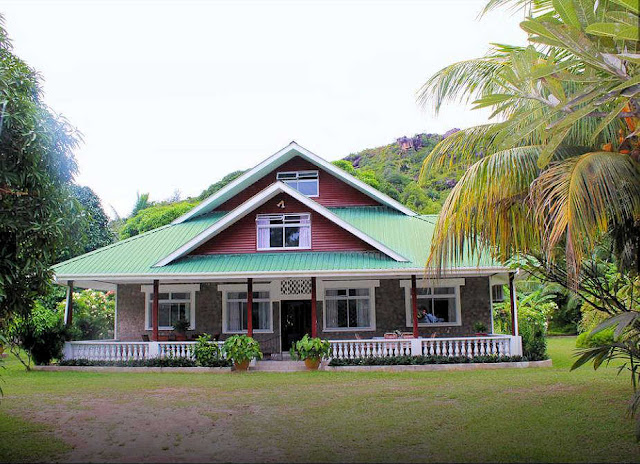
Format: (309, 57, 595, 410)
(190, 193, 374, 255)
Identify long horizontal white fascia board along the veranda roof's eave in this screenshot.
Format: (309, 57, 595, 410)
(55, 267, 513, 285)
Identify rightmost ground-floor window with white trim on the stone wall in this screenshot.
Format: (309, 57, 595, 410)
(400, 279, 464, 327)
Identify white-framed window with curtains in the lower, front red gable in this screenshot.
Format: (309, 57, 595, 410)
(256, 213, 311, 250)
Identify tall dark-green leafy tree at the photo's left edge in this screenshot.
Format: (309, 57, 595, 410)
(0, 19, 78, 321)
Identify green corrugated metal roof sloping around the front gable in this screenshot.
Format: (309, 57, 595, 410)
(53, 206, 496, 277)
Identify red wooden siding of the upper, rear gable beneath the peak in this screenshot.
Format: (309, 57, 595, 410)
(215, 156, 380, 211)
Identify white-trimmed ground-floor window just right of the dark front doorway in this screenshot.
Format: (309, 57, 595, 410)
(324, 288, 375, 331)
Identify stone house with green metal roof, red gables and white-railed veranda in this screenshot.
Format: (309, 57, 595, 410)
(53, 142, 521, 359)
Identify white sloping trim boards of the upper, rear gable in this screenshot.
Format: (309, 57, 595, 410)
(173, 142, 416, 224)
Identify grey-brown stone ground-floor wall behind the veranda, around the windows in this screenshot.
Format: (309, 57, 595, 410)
(117, 277, 491, 343)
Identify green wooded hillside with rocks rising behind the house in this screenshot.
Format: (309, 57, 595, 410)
(117, 129, 465, 239)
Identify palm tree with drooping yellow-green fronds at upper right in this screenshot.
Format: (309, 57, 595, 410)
(419, 0, 640, 278)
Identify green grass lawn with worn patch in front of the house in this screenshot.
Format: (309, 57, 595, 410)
(0, 337, 640, 462)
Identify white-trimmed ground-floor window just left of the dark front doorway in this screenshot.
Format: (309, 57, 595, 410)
(223, 286, 273, 333)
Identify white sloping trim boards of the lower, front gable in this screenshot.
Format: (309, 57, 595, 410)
(154, 182, 408, 267)
